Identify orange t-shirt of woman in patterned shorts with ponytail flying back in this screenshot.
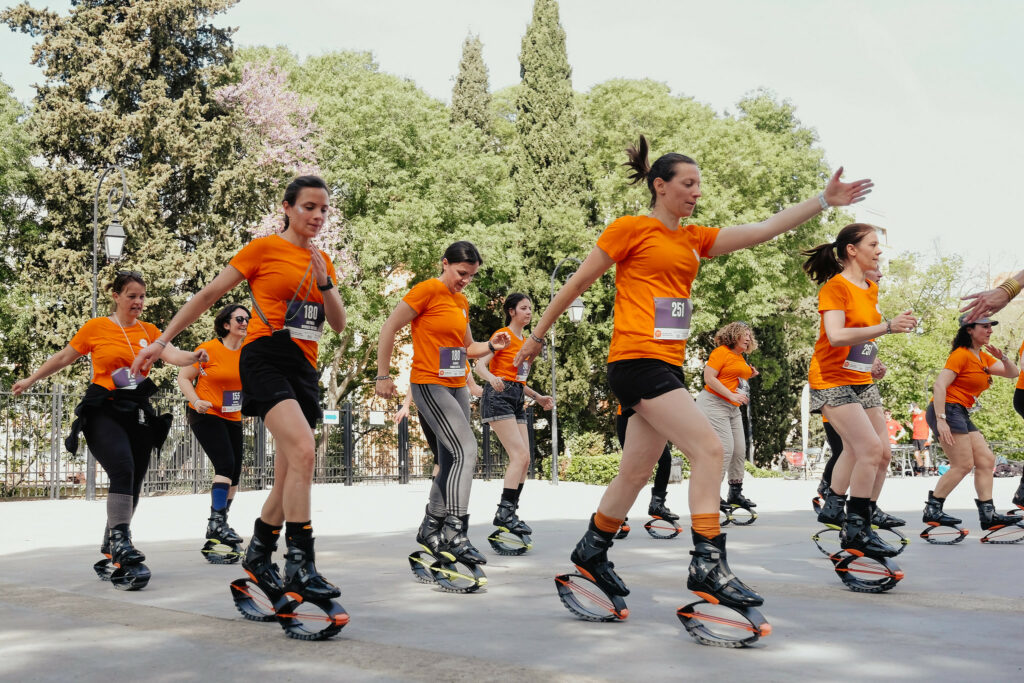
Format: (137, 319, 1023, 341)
(808, 274, 882, 389)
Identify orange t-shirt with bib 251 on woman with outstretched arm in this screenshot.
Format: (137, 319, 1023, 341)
(597, 216, 720, 366)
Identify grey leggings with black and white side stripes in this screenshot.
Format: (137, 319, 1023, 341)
(412, 384, 476, 516)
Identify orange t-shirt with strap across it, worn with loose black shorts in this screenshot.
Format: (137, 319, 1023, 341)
(230, 234, 337, 369)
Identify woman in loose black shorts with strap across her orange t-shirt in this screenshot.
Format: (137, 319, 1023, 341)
(137, 175, 345, 601)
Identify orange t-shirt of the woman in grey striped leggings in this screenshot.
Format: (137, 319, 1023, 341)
(402, 278, 469, 387)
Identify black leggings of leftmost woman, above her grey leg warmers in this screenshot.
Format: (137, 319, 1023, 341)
(82, 408, 153, 505)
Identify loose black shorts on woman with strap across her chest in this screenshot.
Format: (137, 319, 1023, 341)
(239, 330, 324, 429)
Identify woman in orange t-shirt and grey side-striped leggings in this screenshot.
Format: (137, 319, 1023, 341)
(376, 242, 510, 565)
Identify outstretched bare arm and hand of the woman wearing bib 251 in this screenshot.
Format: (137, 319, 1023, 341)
(710, 166, 874, 256)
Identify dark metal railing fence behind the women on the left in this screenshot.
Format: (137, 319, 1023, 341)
(0, 384, 536, 499)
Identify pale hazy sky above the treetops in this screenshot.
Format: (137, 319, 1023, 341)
(0, 0, 1024, 282)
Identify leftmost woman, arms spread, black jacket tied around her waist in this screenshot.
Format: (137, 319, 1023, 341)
(11, 270, 201, 588)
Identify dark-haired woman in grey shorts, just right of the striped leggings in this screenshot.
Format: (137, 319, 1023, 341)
(476, 292, 555, 535)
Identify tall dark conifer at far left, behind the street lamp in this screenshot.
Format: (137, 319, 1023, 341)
(0, 0, 253, 381)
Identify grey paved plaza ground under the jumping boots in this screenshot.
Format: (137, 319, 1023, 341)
(0, 478, 1024, 682)
